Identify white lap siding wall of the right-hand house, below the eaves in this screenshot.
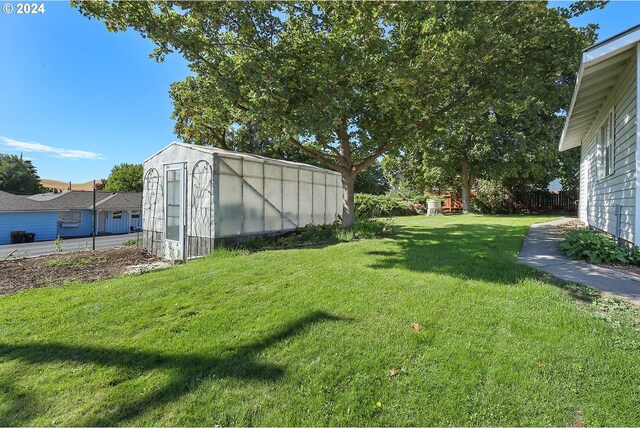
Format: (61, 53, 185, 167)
(579, 57, 637, 242)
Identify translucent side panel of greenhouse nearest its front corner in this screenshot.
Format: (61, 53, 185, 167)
(215, 171, 242, 236)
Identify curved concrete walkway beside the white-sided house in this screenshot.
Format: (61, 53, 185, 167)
(518, 218, 640, 305)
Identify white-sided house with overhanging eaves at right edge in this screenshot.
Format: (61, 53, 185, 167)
(560, 25, 640, 245)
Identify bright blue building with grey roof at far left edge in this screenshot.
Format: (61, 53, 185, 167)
(0, 191, 58, 245)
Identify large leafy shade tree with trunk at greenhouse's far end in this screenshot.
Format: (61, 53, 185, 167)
(73, 1, 596, 224)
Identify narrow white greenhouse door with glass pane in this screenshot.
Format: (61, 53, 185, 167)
(163, 164, 186, 261)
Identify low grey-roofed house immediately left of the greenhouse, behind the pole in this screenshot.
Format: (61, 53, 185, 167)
(29, 190, 142, 238)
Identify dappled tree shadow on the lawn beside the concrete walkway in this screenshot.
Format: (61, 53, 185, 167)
(367, 224, 535, 284)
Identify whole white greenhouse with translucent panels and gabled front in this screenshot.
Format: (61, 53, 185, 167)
(142, 143, 342, 260)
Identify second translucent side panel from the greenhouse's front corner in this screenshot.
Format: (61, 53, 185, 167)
(242, 161, 265, 233)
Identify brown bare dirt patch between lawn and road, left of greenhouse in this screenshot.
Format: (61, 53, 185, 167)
(0, 247, 165, 295)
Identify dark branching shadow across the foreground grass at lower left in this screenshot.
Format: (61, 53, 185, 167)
(0, 312, 348, 426)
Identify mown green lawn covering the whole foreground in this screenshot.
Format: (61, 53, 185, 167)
(0, 216, 640, 425)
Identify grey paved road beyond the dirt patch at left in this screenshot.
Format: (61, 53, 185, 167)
(0, 233, 142, 260)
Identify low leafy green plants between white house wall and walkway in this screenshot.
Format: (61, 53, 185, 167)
(560, 229, 637, 264)
